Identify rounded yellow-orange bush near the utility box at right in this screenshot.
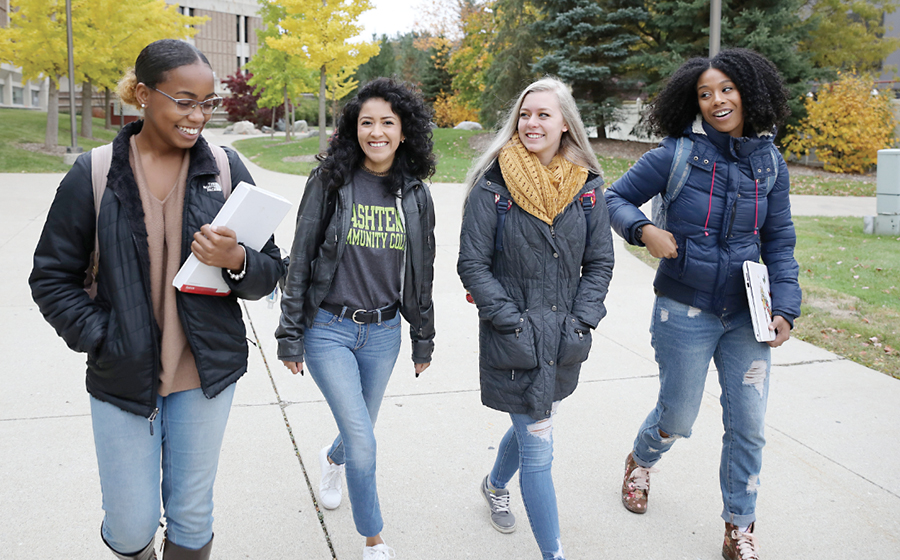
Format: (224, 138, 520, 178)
(784, 74, 896, 173)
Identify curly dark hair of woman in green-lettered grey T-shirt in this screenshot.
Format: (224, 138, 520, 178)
(319, 78, 435, 195)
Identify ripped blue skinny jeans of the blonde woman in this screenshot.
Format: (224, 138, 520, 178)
(491, 402, 564, 560)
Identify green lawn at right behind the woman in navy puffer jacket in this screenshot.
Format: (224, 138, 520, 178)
(628, 216, 900, 378)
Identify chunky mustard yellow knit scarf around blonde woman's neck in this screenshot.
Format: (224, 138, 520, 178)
(497, 134, 588, 224)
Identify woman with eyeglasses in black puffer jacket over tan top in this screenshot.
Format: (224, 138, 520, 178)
(29, 39, 284, 560)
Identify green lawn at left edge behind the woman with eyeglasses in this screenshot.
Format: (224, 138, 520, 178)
(0, 109, 117, 173)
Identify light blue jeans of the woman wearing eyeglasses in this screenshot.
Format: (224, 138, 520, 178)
(91, 383, 234, 554)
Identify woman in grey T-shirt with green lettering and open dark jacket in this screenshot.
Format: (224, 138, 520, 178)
(275, 78, 435, 560)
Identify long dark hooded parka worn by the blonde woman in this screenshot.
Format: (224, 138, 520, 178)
(457, 163, 613, 420)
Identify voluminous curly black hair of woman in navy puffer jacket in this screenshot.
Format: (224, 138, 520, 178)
(649, 49, 791, 137)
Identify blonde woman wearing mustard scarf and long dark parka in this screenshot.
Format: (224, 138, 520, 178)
(457, 78, 613, 560)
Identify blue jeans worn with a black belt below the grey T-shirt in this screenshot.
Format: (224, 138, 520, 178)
(305, 309, 400, 537)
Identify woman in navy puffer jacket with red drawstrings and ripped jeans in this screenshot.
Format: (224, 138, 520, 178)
(606, 49, 800, 560)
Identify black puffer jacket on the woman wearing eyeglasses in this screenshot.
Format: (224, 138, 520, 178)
(29, 121, 284, 418)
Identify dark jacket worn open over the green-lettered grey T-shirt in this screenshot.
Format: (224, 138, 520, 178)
(275, 169, 435, 364)
